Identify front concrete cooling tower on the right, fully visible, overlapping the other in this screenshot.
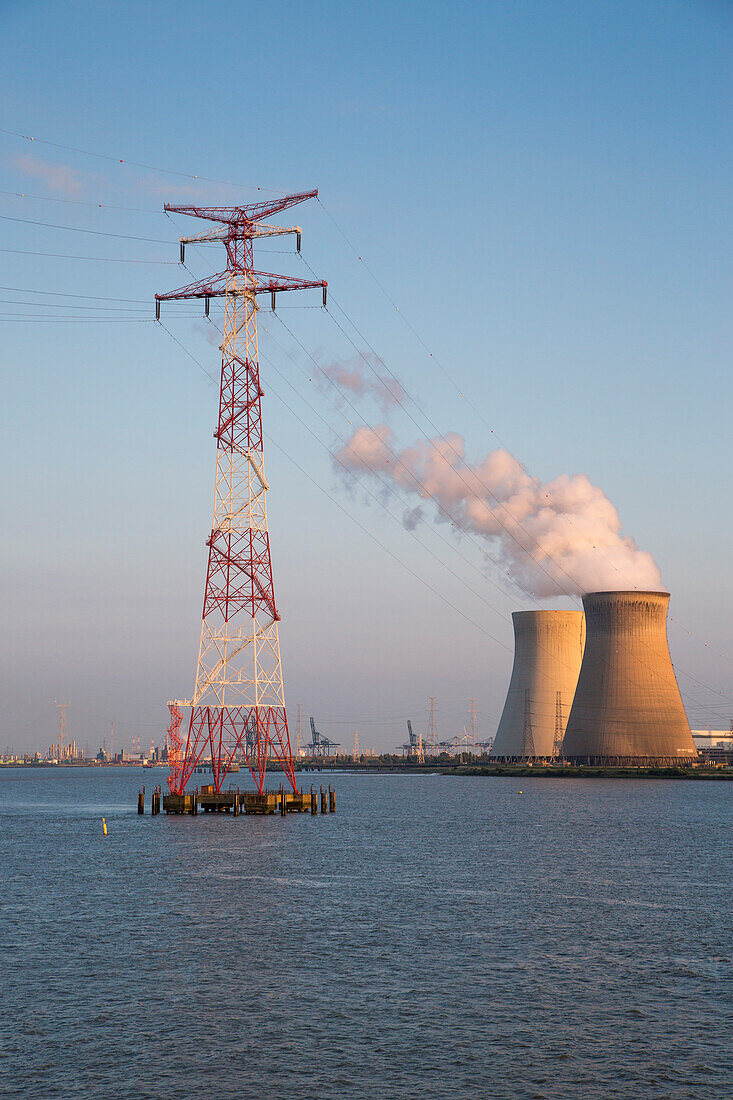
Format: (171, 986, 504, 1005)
(564, 592, 697, 763)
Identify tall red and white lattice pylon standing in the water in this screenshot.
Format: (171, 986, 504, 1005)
(155, 191, 327, 794)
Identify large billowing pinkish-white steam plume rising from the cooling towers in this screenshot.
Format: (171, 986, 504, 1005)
(335, 424, 663, 596)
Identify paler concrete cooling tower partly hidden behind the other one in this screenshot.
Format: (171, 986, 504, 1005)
(491, 612, 584, 757)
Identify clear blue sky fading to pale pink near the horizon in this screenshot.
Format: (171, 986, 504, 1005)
(0, 0, 733, 750)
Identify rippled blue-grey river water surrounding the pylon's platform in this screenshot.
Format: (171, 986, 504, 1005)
(0, 769, 733, 1100)
